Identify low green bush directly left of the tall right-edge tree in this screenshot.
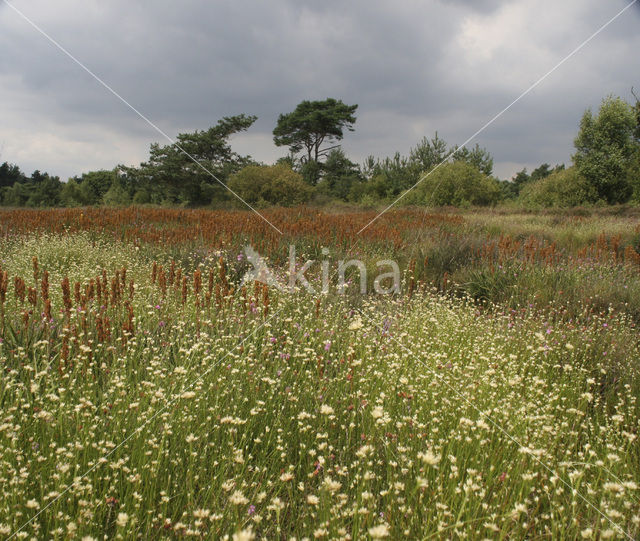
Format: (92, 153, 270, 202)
(519, 167, 598, 208)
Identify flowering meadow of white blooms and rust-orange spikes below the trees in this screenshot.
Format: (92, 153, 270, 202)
(0, 207, 640, 540)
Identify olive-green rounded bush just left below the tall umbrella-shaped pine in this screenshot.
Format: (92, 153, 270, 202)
(228, 165, 313, 207)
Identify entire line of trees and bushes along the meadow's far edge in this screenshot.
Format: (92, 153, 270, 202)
(0, 96, 640, 207)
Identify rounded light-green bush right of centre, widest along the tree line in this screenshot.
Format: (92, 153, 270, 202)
(404, 161, 501, 207)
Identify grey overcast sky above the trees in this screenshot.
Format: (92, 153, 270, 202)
(0, 0, 640, 180)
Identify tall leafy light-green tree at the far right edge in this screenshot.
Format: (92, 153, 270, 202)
(573, 96, 638, 204)
